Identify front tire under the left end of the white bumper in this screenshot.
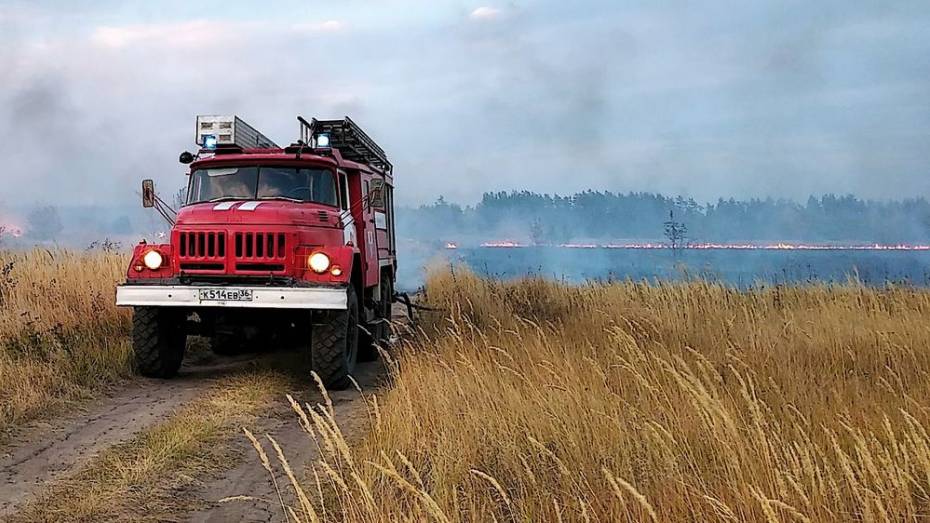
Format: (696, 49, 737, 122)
(132, 307, 187, 378)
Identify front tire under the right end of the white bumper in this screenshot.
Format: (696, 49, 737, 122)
(310, 285, 359, 390)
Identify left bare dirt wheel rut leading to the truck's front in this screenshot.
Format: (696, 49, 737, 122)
(0, 358, 257, 519)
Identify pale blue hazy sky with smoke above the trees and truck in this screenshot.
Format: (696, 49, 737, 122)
(0, 0, 930, 205)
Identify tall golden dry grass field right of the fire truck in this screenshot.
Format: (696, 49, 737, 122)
(257, 272, 930, 522)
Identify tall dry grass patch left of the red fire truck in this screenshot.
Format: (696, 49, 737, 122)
(0, 249, 131, 438)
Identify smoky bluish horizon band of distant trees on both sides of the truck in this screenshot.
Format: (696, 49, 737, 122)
(0, 186, 930, 246)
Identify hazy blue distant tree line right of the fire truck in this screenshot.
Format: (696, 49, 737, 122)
(397, 190, 930, 244)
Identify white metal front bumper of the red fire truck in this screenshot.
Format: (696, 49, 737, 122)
(116, 284, 347, 310)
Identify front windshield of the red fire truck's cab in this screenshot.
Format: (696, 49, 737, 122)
(187, 167, 337, 206)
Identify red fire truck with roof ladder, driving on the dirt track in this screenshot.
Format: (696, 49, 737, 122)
(116, 116, 397, 388)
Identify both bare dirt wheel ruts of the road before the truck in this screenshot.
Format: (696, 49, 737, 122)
(0, 354, 383, 521)
